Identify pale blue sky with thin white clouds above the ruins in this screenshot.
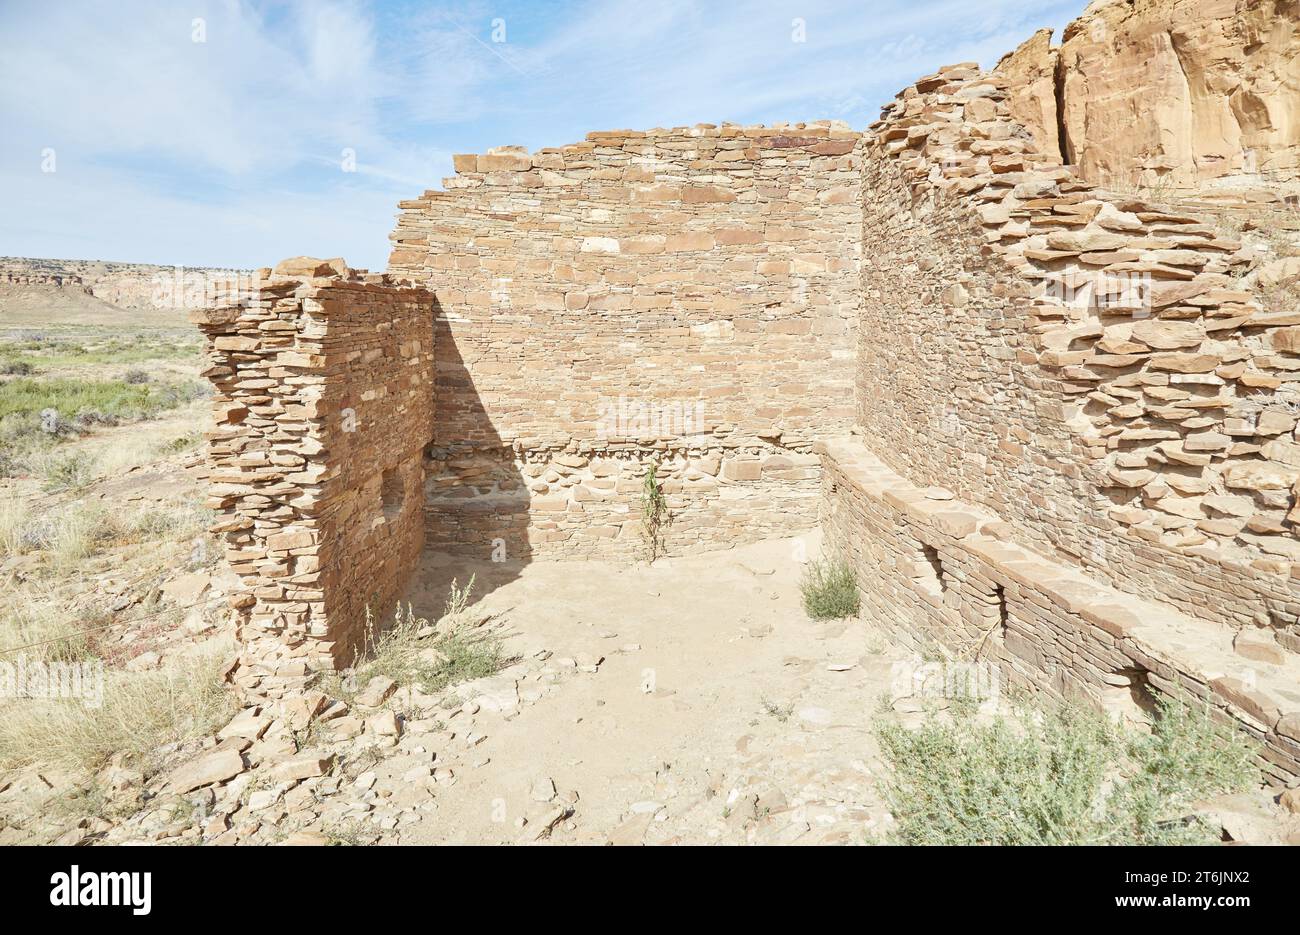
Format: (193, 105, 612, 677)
(0, 0, 1084, 269)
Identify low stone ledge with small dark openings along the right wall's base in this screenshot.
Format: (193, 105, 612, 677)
(818, 438, 1300, 782)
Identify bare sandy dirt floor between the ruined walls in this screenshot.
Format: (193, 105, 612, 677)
(400, 536, 905, 844)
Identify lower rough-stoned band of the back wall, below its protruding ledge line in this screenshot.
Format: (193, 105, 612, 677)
(426, 442, 820, 560)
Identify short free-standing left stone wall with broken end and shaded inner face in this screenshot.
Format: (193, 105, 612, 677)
(191, 259, 433, 694)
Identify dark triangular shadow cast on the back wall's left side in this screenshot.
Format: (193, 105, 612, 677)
(406, 299, 533, 620)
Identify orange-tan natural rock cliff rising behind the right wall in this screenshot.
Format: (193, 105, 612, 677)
(997, 0, 1300, 186)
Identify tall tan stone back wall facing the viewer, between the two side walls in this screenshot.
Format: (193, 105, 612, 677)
(390, 124, 861, 559)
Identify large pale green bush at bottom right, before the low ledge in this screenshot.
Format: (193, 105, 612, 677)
(876, 700, 1260, 845)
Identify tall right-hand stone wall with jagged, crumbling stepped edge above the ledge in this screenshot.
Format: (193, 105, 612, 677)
(858, 66, 1300, 649)
